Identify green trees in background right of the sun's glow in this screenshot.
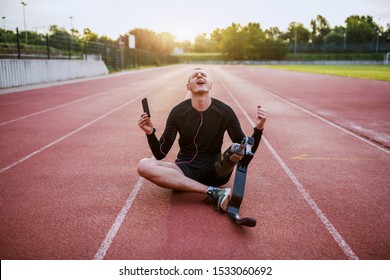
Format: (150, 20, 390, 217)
(191, 15, 390, 60)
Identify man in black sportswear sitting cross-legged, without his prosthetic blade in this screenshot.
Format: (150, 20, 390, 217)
(137, 68, 268, 211)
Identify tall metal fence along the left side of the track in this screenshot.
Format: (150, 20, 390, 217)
(0, 28, 179, 71)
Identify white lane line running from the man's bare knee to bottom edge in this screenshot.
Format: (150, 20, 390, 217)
(93, 177, 144, 260)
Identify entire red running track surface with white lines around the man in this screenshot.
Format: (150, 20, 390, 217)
(0, 65, 390, 259)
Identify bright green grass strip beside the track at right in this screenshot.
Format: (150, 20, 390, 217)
(261, 65, 390, 82)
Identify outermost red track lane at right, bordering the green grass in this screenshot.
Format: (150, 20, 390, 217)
(221, 67, 390, 151)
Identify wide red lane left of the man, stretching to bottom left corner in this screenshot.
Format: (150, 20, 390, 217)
(0, 65, 191, 259)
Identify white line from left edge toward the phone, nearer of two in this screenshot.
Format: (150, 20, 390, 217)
(0, 89, 155, 174)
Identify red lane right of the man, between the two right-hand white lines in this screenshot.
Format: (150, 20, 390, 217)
(212, 64, 390, 259)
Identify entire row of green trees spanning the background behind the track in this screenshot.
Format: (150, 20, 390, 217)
(0, 15, 390, 60)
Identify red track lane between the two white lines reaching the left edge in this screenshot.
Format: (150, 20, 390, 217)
(0, 67, 186, 172)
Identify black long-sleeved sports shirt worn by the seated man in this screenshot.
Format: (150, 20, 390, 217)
(148, 98, 262, 166)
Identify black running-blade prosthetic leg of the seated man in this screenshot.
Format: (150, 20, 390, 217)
(227, 136, 256, 227)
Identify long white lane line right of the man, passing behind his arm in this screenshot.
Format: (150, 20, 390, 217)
(218, 71, 359, 260)
